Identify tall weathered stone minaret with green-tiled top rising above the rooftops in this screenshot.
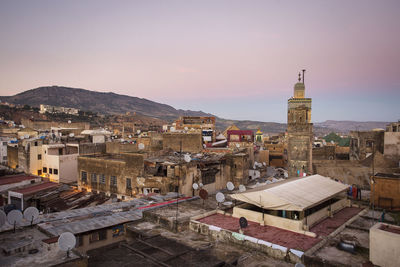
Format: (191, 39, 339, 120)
(287, 70, 314, 177)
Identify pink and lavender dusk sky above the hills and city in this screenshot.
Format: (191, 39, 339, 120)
(0, 0, 400, 122)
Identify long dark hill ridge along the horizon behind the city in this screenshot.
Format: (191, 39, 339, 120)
(0, 86, 387, 135)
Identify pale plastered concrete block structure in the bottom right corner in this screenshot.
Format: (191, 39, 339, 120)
(369, 223, 400, 267)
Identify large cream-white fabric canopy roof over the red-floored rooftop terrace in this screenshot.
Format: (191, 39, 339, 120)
(231, 174, 348, 211)
